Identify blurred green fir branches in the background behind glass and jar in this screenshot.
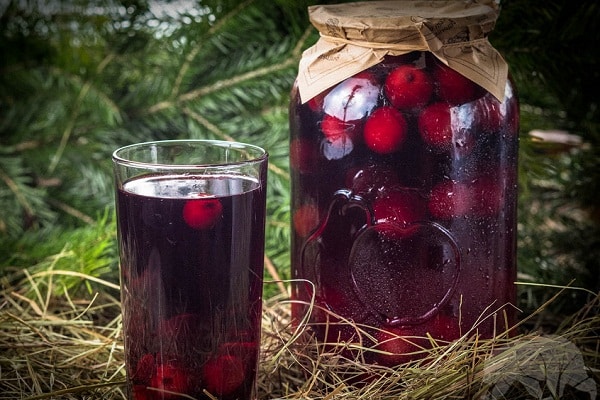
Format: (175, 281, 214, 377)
(0, 0, 600, 313)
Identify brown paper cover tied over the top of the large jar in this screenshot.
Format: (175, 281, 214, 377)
(298, 0, 508, 102)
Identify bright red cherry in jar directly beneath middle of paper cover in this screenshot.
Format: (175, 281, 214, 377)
(384, 64, 433, 110)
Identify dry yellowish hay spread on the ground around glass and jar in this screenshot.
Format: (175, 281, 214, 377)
(0, 272, 600, 400)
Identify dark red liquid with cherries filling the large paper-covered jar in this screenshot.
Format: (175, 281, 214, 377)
(290, 52, 518, 364)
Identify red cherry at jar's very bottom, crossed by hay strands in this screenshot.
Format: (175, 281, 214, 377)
(375, 328, 422, 367)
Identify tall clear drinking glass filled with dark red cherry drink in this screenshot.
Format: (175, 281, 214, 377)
(113, 140, 268, 400)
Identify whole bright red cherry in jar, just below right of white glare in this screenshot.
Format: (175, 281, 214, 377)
(363, 106, 407, 154)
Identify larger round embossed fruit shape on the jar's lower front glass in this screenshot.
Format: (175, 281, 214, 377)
(348, 222, 460, 326)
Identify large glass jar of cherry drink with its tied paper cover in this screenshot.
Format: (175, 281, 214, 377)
(290, 1, 519, 364)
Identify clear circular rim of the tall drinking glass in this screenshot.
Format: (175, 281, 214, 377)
(112, 139, 269, 169)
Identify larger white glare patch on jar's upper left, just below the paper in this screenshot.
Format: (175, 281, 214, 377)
(323, 71, 379, 121)
